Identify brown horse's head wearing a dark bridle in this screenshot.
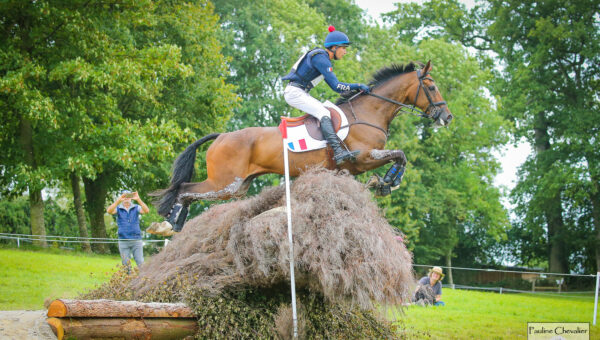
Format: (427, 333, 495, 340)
(407, 60, 452, 126)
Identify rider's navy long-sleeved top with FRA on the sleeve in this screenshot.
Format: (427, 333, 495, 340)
(282, 49, 358, 92)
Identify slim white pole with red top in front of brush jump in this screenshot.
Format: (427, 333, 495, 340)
(280, 119, 298, 339)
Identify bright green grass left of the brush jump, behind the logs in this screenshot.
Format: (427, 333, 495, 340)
(0, 248, 121, 310)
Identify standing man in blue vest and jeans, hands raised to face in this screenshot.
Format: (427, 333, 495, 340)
(106, 190, 150, 273)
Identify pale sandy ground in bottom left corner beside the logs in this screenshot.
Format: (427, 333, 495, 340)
(0, 310, 56, 340)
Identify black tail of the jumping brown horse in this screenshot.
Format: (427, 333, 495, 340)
(152, 133, 220, 217)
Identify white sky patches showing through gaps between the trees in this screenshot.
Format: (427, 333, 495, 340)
(354, 0, 531, 194)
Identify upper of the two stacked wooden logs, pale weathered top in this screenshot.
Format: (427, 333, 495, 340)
(48, 299, 195, 318)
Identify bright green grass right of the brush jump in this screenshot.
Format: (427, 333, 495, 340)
(389, 289, 600, 339)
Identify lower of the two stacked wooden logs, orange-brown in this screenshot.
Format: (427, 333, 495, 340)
(48, 318, 198, 340)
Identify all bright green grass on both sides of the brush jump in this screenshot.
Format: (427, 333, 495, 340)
(0, 248, 600, 339)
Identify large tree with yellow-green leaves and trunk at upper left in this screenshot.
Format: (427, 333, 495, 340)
(0, 1, 236, 252)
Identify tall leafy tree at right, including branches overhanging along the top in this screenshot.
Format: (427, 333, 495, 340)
(389, 0, 600, 272)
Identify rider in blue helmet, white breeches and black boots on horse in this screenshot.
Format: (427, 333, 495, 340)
(282, 26, 369, 165)
